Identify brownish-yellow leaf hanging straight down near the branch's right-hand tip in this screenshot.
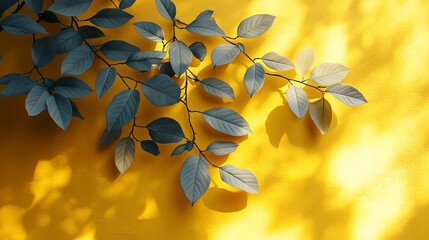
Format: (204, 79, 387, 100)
(310, 98, 332, 134)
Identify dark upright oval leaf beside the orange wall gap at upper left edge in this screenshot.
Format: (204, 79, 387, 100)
(31, 37, 55, 67)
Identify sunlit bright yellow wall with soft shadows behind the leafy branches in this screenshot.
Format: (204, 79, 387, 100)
(0, 0, 429, 240)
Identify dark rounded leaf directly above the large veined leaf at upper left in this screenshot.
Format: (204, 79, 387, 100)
(54, 28, 84, 53)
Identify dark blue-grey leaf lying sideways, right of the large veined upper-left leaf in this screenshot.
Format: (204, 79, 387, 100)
(100, 40, 140, 61)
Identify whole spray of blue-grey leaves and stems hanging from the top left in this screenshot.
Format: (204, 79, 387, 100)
(0, 0, 366, 205)
